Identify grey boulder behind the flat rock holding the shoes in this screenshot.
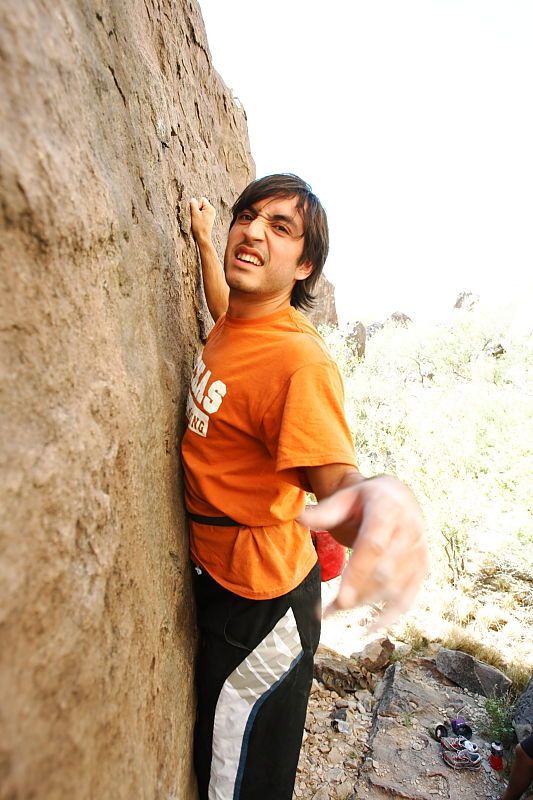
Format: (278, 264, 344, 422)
(435, 648, 512, 697)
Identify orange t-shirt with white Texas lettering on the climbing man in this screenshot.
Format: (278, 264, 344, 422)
(182, 307, 356, 599)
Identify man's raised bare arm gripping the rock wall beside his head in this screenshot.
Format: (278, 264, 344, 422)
(191, 197, 229, 322)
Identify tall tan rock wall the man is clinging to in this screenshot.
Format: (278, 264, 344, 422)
(0, 0, 253, 800)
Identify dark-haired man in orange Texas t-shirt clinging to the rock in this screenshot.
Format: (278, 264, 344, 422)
(182, 175, 427, 800)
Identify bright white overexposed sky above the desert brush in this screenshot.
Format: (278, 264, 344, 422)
(200, 0, 533, 323)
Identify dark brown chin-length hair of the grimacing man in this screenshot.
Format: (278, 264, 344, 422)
(230, 173, 329, 309)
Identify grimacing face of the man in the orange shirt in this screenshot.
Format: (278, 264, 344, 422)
(224, 197, 313, 307)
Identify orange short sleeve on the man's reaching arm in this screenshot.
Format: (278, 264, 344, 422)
(262, 362, 357, 491)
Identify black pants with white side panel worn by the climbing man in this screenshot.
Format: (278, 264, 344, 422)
(194, 565, 320, 800)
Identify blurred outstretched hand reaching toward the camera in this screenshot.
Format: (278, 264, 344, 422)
(299, 475, 428, 630)
